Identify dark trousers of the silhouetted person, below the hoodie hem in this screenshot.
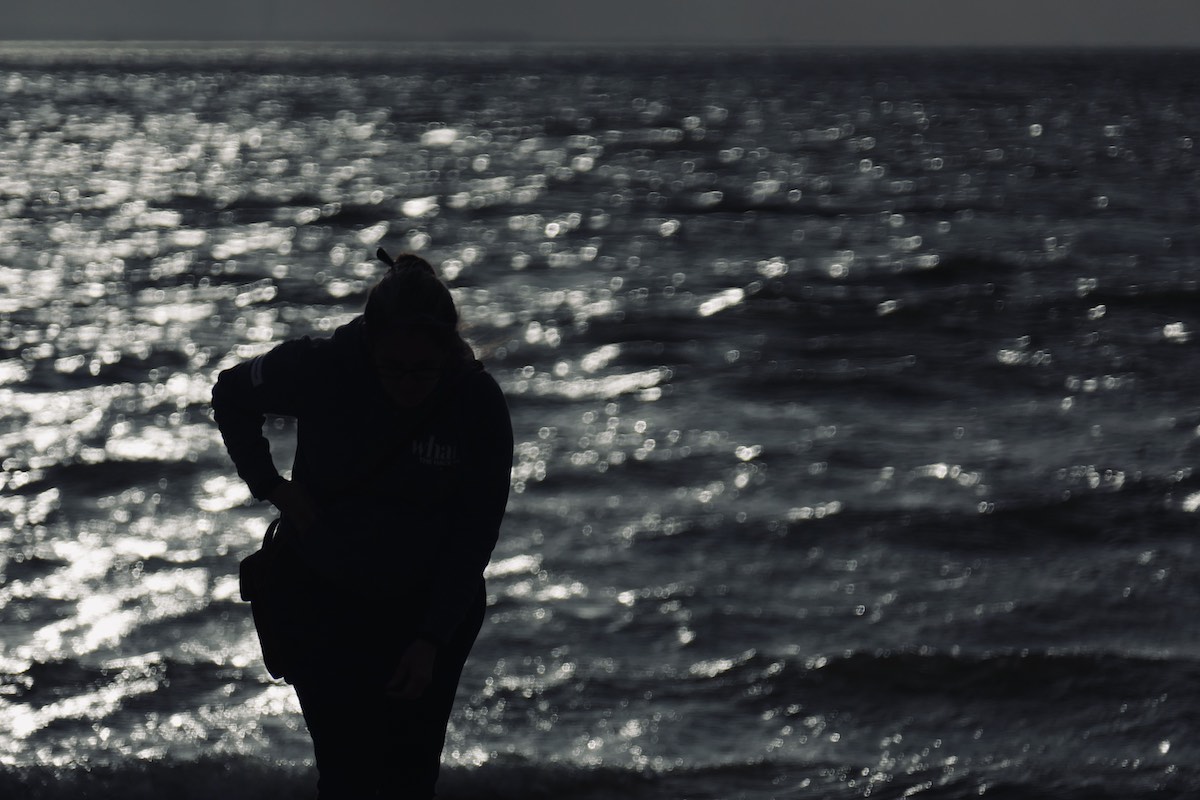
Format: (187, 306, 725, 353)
(289, 587, 486, 800)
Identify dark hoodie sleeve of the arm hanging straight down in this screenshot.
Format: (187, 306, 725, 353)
(418, 372, 512, 645)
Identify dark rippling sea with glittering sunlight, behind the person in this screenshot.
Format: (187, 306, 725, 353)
(0, 43, 1200, 800)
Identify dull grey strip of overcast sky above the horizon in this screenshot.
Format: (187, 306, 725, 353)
(7, 0, 1200, 47)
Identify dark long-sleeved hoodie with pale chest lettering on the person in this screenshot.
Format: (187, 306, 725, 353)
(212, 317, 512, 644)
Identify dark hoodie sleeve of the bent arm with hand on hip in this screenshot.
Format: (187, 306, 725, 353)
(212, 337, 314, 500)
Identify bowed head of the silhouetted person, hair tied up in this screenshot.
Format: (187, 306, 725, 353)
(364, 251, 473, 408)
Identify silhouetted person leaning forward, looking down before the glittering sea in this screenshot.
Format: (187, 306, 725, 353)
(212, 251, 512, 800)
